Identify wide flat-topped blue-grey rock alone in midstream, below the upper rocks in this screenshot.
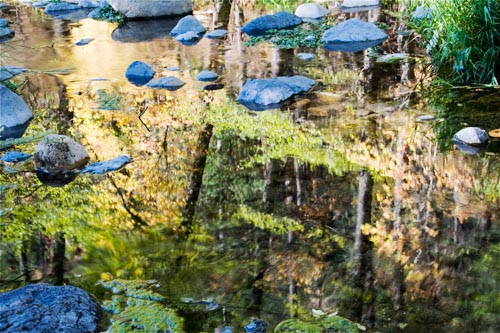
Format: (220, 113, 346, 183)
(238, 75, 315, 111)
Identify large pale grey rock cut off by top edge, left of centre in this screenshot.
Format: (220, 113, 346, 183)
(108, 0, 193, 19)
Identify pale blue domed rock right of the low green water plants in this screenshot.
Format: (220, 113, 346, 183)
(321, 18, 387, 52)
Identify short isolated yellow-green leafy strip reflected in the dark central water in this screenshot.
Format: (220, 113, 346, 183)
(233, 205, 304, 235)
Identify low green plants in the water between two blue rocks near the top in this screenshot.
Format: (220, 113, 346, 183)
(245, 21, 331, 49)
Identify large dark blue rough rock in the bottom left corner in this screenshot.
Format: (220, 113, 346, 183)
(0, 283, 102, 333)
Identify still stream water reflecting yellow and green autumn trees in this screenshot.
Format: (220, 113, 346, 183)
(0, 1, 500, 332)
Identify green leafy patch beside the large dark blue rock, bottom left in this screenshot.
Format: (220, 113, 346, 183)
(100, 280, 184, 333)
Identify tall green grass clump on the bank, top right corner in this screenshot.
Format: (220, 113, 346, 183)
(413, 0, 500, 85)
